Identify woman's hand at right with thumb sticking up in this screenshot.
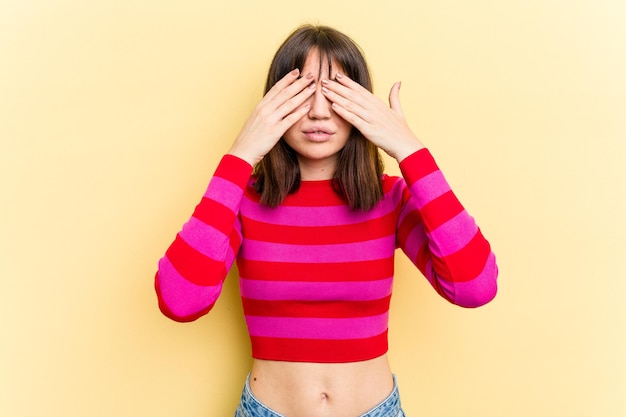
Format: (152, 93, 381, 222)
(322, 73, 424, 162)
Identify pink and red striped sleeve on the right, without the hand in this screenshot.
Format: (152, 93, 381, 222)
(398, 149, 498, 307)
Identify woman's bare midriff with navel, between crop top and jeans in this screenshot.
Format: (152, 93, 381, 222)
(250, 355, 393, 417)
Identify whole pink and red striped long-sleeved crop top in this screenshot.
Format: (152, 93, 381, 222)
(155, 149, 498, 362)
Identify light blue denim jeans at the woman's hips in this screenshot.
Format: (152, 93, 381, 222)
(235, 375, 406, 417)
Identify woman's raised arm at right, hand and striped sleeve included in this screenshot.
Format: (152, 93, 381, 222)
(322, 74, 498, 307)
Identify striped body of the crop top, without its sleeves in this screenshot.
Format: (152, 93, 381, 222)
(236, 178, 406, 363)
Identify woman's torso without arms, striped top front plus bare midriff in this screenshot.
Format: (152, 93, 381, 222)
(237, 179, 401, 417)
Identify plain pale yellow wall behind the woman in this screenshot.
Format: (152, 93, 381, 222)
(0, 0, 626, 417)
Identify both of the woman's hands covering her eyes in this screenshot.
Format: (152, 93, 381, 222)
(229, 69, 423, 166)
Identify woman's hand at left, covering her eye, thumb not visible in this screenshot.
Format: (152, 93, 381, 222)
(228, 69, 315, 166)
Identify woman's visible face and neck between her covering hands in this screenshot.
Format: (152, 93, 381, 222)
(283, 49, 352, 181)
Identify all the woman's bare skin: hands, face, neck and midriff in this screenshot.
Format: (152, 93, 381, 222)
(229, 50, 423, 417)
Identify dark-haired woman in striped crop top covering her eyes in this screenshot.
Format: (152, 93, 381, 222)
(156, 26, 497, 417)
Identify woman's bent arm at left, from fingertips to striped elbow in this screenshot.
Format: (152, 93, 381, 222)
(155, 69, 315, 321)
